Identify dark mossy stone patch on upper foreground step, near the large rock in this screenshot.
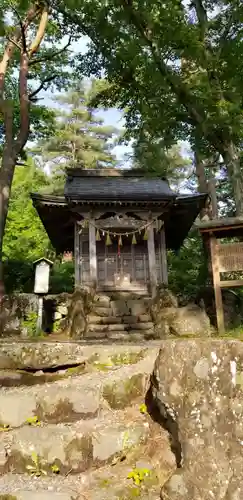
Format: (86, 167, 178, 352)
(103, 373, 145, 410)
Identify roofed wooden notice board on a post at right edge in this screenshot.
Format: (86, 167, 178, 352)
(198, 217, 243, 334)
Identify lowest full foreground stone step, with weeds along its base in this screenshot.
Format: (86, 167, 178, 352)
(0, 409, 149, 475)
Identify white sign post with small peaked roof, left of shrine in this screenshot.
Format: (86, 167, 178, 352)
(34, 257, 53, 332)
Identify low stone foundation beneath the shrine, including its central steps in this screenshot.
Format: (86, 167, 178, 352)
(0, 287, 212, 341)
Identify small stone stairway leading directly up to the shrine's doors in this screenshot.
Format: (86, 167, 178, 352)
(86, 292, 154, 341)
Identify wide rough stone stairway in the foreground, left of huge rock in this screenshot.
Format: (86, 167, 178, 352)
(0, 342, 176, 500)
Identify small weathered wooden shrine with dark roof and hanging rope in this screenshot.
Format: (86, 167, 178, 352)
(31, 169, 207, 293)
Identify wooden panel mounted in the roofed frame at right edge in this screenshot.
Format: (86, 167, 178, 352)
(217, 243, 243, 273)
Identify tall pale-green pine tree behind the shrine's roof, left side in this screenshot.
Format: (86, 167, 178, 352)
(41, 84, 116, 191)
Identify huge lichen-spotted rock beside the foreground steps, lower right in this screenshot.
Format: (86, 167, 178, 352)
(150, 339, 243, 500)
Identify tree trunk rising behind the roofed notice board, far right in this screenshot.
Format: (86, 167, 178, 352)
(222, 142, 243, 215)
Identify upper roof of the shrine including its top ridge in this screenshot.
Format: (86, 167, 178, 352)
(64, 169, 176, 202)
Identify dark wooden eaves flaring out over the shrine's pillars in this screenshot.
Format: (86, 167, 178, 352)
(31, 194, 207, 253)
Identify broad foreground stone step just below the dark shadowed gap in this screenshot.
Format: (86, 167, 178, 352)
(0, 348, 158, 428)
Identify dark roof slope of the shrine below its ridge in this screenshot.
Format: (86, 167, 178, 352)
(64, 176, 176, 201)
